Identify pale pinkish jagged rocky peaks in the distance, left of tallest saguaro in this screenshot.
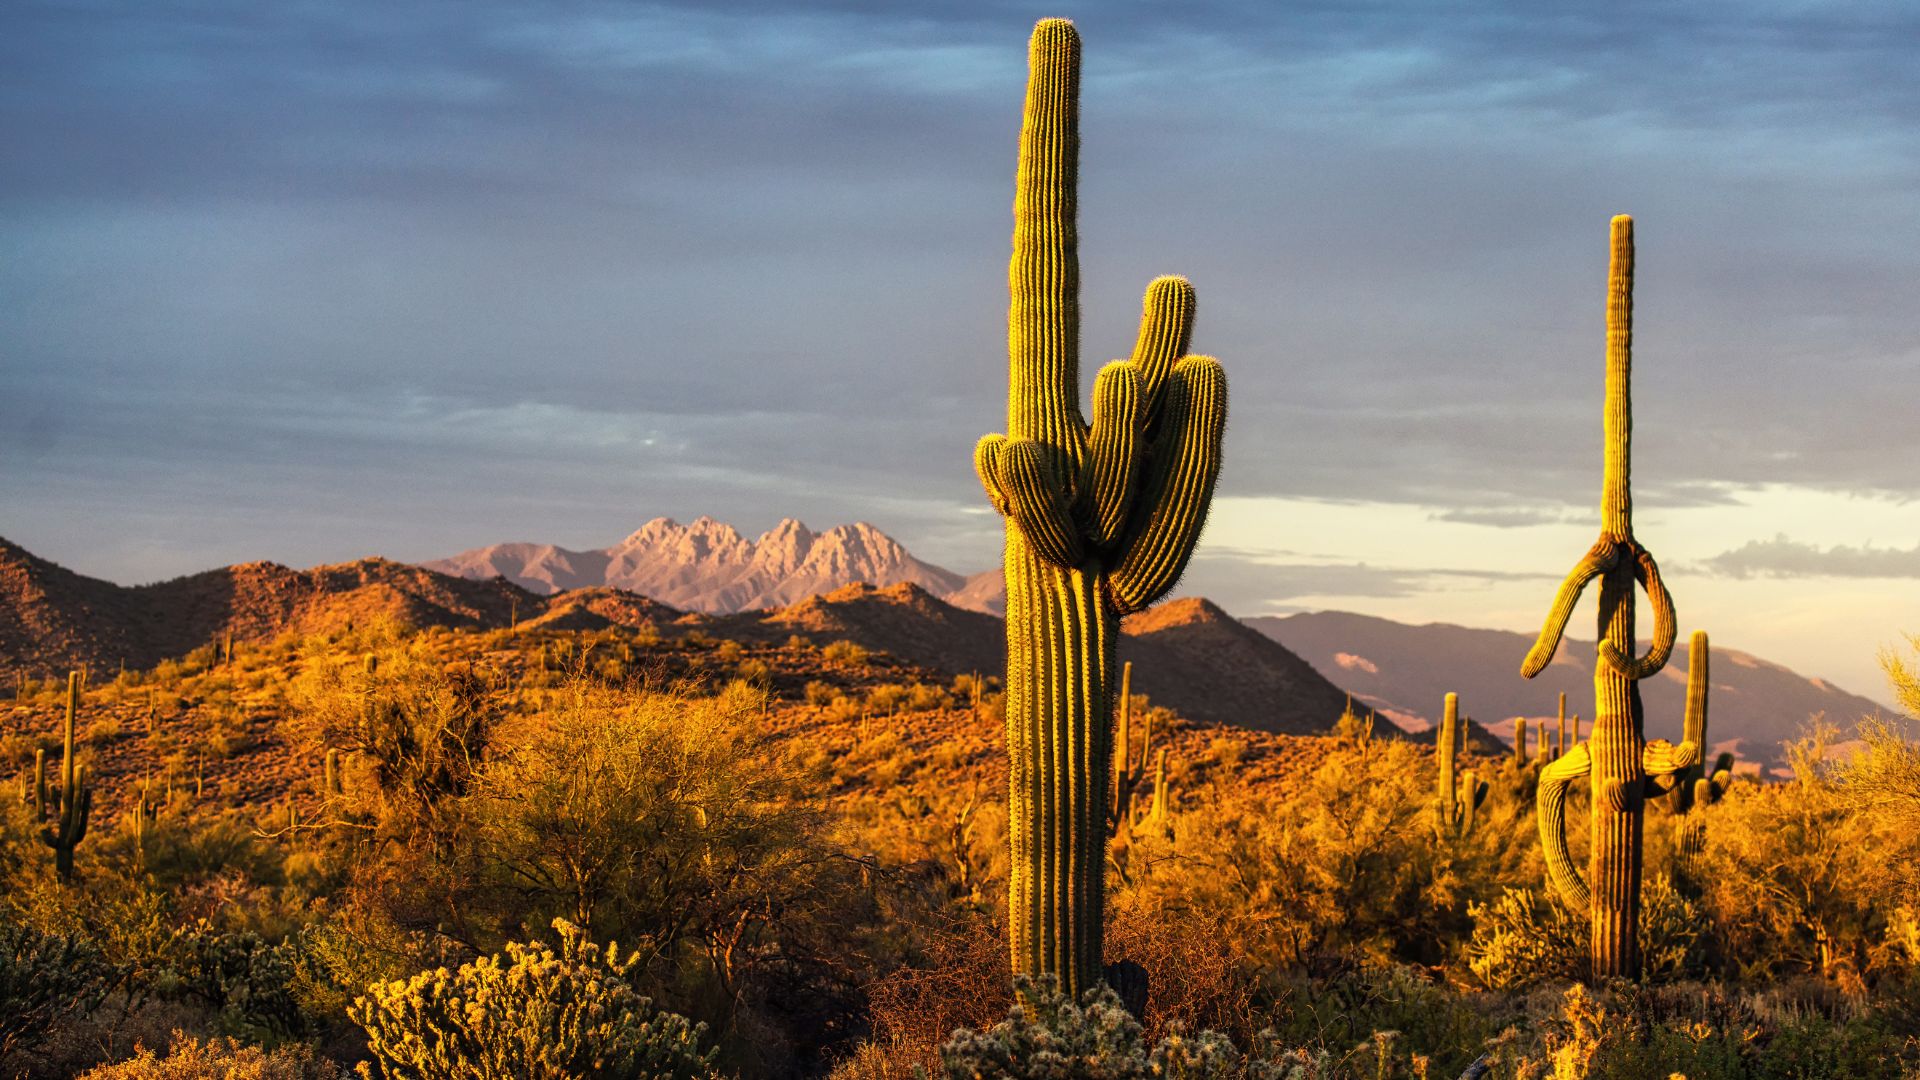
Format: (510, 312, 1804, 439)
(422, 517, 991, 615)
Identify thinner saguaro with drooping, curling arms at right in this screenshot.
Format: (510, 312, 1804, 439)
(1521, 215, 1699, 980)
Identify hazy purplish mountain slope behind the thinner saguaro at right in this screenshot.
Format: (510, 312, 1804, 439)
(1246, 611, 1880, 761)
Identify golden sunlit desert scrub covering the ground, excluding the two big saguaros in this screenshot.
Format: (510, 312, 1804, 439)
(0, 626, 1920, 1078)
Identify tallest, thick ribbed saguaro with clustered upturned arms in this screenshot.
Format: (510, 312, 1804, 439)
(973, 19, 1227, 994)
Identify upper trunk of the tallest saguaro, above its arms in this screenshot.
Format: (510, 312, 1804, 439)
(1006, 19, 1087, 457)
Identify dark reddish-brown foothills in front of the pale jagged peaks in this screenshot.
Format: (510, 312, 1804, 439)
(0, 534, 1367, 734)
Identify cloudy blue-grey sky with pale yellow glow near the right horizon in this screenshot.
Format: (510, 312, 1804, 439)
(0, 0, 1920, 698)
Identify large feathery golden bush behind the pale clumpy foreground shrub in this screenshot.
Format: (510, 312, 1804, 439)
(447, 682, 876, 1070)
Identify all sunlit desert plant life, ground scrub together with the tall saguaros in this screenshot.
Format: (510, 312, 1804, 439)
(0, 19, 1920, 1080)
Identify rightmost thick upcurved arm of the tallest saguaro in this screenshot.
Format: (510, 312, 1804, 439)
(1110, 356, 1227, 615)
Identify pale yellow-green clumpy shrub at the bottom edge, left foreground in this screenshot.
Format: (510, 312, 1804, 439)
(349, 919, 714, 1080)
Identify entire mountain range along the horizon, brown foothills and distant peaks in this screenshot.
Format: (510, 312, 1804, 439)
(0, 517, 1878, 761)
